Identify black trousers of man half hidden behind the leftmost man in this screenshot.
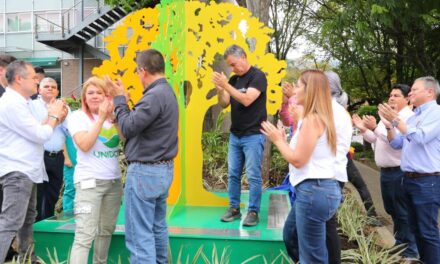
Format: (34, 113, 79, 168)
(37, 151, 64, 221)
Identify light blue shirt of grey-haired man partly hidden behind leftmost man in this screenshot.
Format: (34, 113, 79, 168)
(29, 96, 67, 151)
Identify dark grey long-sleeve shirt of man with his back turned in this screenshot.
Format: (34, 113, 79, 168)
(113, 78, 179, 162)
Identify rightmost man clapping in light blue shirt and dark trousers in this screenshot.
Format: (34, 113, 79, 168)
(379, 76, 440, 264)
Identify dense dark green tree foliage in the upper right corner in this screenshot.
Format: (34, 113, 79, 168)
(308, 0, 440, 104)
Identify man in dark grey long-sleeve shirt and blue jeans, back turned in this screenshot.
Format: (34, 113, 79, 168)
(106, 49, 179, 264)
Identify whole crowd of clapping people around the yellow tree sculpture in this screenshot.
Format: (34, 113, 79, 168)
(0, 45, 440, 264)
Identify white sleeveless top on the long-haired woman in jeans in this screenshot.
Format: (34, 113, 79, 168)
(289, 121, 336, 186)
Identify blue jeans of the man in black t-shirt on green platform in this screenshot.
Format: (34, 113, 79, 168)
(228, 133, 266, 213)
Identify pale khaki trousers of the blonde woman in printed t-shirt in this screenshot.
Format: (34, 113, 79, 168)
(70, 179, 122, 264)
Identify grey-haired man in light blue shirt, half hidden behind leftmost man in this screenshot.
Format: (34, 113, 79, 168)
(29, 77, 67, 221)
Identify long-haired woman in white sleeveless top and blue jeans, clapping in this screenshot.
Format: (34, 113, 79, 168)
(262, 70, 342, 264)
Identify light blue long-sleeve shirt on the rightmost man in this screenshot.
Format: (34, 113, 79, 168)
(390, 100, 440, 173)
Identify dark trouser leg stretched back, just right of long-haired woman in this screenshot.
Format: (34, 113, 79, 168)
(347, 159, 377, 217)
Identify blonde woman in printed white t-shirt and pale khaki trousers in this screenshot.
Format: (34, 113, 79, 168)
(68, 77, 122, 264)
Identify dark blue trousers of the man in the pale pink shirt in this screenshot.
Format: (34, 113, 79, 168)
(380, 167, 418, 258)
